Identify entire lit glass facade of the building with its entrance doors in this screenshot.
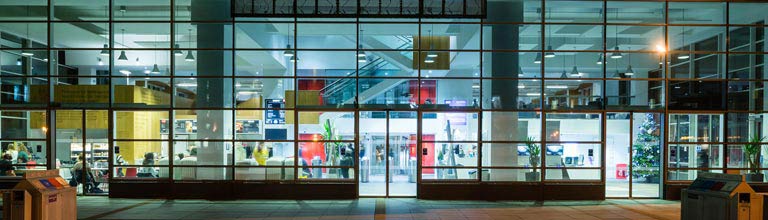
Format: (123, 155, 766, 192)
(0, 0, 768, 197)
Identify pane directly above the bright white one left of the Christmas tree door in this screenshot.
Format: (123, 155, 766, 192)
(544, 79, 605, 110)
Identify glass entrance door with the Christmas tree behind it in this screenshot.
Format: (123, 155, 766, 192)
(605, 112, 662, 198)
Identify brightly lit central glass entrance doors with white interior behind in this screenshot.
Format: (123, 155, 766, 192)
(358, 111, 418, 197)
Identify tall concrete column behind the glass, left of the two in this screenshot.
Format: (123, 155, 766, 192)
(191, 0, 234, 179)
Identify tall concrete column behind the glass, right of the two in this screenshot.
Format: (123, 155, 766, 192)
(483, 0, 523, 181)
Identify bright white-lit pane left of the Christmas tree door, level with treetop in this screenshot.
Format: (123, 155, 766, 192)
(545, 113, 603, 142)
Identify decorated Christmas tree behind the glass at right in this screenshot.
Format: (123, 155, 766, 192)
(632, 113, 661, 181)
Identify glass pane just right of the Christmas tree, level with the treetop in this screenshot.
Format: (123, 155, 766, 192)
(668, 114, 724, 142)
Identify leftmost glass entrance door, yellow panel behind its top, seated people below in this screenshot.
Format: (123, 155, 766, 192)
(54, 110, 109, 195)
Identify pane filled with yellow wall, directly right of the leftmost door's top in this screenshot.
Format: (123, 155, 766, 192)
(114, 111, 170, 140)
